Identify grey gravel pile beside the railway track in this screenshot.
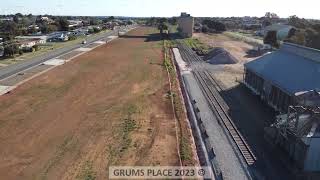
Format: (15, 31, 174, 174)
(204, 47, 239, 64)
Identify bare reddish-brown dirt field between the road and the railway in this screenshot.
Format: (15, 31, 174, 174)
(0, 28, 179, 180)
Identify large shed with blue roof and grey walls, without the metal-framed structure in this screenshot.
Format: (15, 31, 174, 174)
(244, 43, 320, 112)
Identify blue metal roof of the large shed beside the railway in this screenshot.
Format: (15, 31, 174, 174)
(244, 43, 320, 95)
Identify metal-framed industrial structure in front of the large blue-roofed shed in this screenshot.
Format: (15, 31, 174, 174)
(264, 91, 320, 180)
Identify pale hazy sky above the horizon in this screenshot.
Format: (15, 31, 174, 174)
(0, 0, 320, 19)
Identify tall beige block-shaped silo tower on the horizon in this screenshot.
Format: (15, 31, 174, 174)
(178, 13, 194, 37)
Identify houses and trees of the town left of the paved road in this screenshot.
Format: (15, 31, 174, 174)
(0, 13, 134, 58)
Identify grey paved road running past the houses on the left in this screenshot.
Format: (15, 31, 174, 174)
(0, 27, 127, 80)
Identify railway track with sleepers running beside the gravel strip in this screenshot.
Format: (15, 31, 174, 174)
(178, 41, 257, 166)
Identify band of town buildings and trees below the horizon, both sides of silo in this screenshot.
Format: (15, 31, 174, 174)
(0, 12, 320, 59)
